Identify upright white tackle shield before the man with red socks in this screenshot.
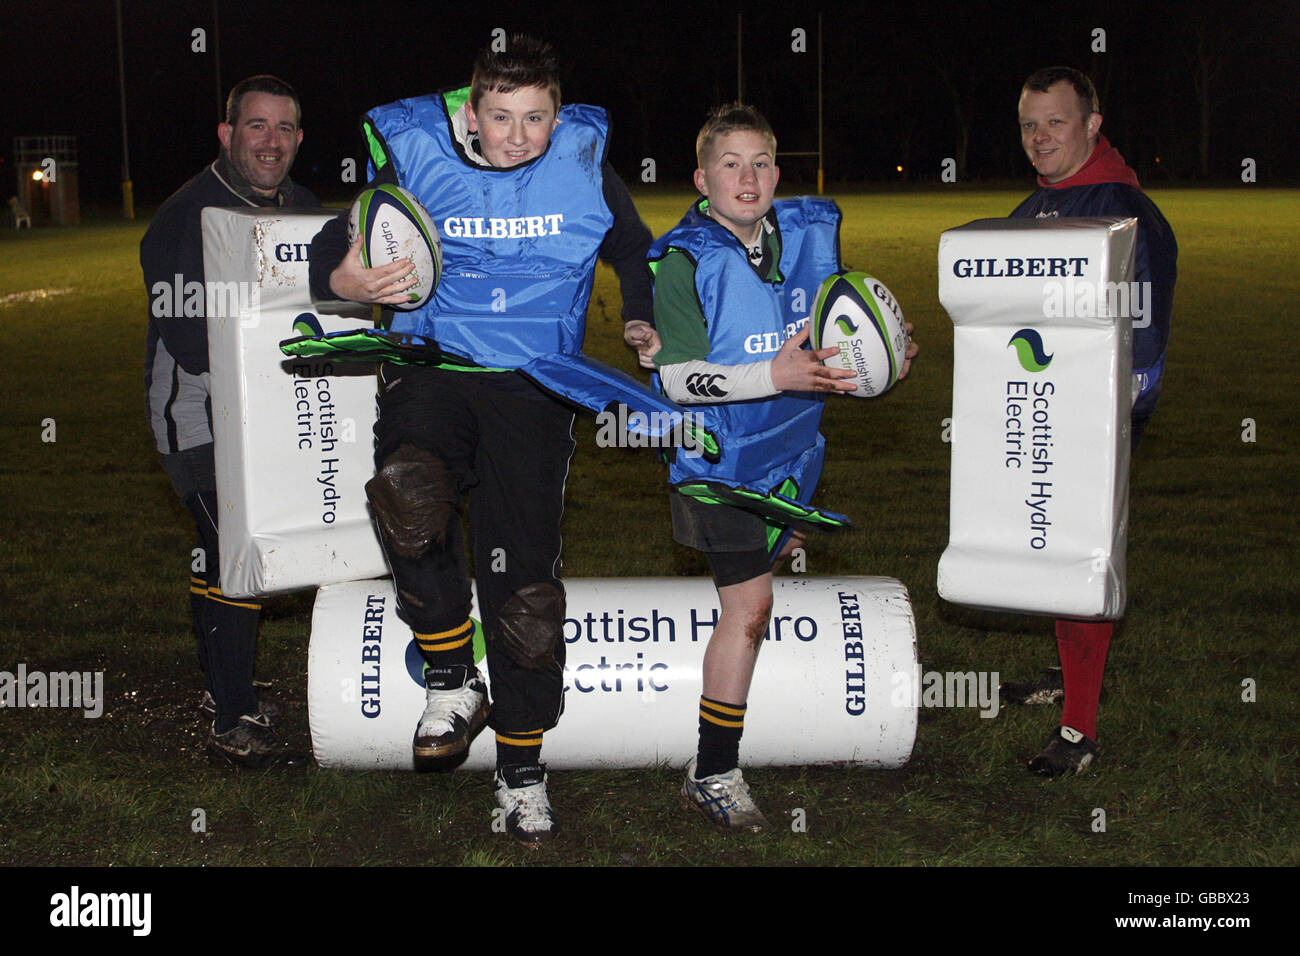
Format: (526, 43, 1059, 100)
(939, 219, 1138, 619)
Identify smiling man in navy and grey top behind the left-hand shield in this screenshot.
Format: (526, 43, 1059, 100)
(140, 75, 320, 766)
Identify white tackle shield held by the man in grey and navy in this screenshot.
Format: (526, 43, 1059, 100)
(203, 208, 387, 597)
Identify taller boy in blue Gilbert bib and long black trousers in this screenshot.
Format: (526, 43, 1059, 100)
(311, 36, 653, 847)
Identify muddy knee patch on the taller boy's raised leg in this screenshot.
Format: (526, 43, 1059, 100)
(365, 445, 456, 561)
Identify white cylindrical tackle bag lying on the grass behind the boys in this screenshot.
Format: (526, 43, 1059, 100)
(307, 575, 920, 770)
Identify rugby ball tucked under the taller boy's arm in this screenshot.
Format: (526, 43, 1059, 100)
(347, 185, 442, 312)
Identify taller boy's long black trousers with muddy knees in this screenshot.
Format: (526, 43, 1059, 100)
(374, 364, 575, 734)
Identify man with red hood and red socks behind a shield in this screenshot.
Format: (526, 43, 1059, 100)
(1000, 66, 1178, 777)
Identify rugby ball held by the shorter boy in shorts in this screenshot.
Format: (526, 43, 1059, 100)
(810, 272, 907, 398)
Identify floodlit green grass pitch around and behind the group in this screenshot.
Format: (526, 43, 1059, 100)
(0, 187, 1300, 866)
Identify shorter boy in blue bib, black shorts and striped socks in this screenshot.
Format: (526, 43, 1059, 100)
(650, 104, 906, 831)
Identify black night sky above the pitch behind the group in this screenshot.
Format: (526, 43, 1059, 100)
(0, 0, 1300, 206)
